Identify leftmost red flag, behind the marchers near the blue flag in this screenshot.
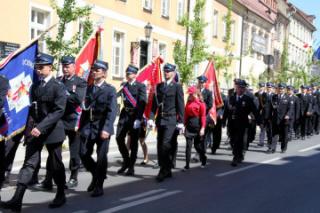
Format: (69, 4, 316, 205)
(75, 27, 103, 130)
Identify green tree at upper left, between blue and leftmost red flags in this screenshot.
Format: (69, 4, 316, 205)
(46, 0, 93, 67)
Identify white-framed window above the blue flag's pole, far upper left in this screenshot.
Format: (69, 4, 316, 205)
(30, 8, 50, 52)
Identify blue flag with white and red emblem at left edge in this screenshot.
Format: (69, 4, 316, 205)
(0, 41, 38, 138)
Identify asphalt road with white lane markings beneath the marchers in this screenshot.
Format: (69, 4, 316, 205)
(1, 131, 320, 213)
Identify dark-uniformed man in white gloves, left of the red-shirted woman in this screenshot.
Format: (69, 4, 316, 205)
(148, 63, 184, 182)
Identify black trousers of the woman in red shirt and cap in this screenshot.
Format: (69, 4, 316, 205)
(186, 132, 206, 167)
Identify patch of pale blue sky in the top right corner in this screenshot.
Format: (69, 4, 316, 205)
(289, 0, 320, 49)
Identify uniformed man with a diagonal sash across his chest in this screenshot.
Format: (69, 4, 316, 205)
(116, 65, 147, 176)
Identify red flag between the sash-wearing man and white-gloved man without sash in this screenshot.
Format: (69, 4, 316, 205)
(136, 56, 163, 119)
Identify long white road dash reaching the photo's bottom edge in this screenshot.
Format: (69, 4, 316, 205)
(100, 190, 182, 213)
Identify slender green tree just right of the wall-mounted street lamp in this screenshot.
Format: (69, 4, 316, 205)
(173, 0, 209, 84)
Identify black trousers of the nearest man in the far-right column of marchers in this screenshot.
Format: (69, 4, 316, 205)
(272, 119, 289, 151)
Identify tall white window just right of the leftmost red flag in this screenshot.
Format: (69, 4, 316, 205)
(112, 32, 124, 77)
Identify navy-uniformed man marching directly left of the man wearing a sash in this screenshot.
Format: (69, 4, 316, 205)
(79, 60, 117, 197)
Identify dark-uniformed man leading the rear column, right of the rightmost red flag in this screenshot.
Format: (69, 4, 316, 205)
(226, 80, 259, 166)
